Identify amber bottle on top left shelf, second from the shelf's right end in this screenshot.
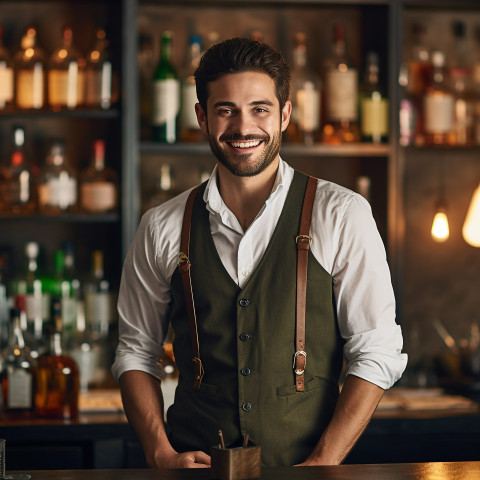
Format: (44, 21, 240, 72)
(48, 27, 85, 111)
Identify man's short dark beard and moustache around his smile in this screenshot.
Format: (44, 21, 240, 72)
(208, 132, 282, 177)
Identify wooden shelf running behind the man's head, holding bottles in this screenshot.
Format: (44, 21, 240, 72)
(140, 142, 390, 157)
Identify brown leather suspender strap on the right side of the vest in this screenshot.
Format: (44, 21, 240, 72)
(293, 177, 317, 392)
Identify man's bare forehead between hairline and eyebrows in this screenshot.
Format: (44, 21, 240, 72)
(207, 71, 278, 105)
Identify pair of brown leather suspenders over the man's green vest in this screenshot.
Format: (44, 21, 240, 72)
(178, 177, 317, 392)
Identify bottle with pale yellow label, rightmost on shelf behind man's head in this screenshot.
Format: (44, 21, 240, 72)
(360, 52, 388, 143)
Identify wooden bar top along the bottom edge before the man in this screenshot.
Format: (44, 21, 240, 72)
(7, 462, 480, 480)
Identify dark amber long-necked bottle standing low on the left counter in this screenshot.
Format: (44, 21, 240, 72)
(35, 300, 80, 419)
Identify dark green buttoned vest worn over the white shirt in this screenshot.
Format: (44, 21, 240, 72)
(167, 172, 343, 466)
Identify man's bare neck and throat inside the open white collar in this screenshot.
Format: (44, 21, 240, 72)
(217, 158, 279, 232)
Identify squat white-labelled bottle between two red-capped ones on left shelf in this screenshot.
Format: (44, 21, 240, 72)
(38, 140, 77, 215)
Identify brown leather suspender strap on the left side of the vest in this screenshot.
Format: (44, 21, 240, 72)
(178, 187, 205, 390)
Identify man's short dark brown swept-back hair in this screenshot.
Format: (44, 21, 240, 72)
(195, 37, 290, 112)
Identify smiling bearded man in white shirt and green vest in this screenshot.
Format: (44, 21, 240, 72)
(113, 38, 406, 468)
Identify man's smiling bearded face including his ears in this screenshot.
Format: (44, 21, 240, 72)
(196, 71, 291, 177)
